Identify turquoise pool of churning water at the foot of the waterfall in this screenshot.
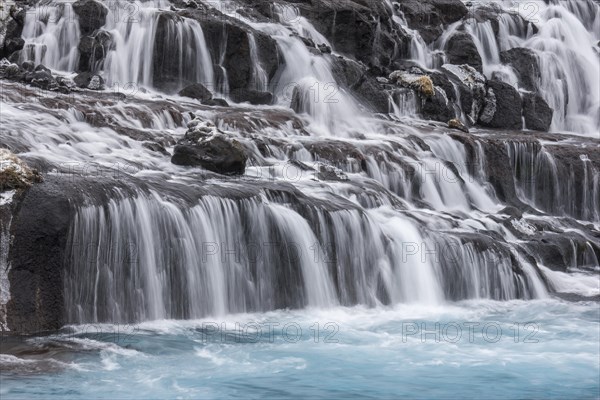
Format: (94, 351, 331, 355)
(0, 300, 600, 399)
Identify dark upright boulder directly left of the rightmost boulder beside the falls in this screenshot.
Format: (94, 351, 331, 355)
(480, 80, 523, 129)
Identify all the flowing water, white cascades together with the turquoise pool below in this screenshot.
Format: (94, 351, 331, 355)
(0, 0, 600, 398)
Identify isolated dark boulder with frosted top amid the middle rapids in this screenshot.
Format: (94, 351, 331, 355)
(171, 131, 248, 175)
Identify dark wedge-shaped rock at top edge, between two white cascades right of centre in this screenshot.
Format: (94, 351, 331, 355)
(398, 0, 469, 43)
